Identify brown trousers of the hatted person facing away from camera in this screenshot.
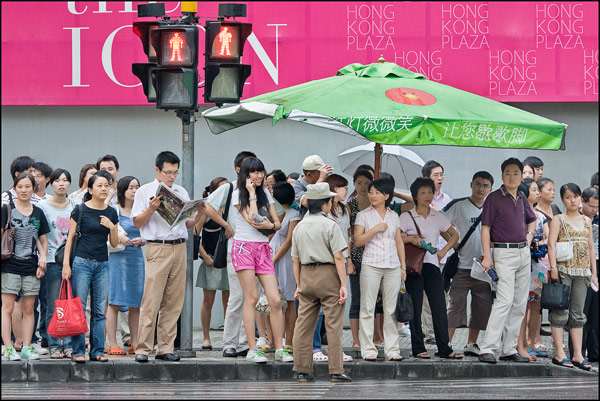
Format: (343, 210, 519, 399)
(293, 265, 344, 375)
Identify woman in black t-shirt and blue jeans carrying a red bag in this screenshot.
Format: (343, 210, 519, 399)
(62, 172, 119, 363)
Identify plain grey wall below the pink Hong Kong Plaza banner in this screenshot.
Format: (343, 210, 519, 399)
(1, 103, 598, 327)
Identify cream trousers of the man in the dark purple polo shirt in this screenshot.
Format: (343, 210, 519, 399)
(480, 247, 531, 356)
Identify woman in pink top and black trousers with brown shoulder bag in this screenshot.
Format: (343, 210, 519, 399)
(400, 178, 462, 359)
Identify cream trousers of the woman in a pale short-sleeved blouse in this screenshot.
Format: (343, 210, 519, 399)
(358, 263, 402, 359)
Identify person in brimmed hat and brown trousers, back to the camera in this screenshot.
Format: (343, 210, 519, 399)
(292, 181, 352, 382)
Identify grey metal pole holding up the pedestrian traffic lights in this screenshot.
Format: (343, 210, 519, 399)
(177, 110, 196, 358)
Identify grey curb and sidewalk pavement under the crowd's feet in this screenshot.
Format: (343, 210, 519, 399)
(2, 329, 598, 382)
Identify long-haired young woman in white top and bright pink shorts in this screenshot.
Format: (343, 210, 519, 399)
(231, 157, 294, 363)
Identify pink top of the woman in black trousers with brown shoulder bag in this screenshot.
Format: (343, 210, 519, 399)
(400, 208, 450, 267)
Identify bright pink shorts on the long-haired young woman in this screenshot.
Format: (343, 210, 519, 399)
(231, 240, 275, 274)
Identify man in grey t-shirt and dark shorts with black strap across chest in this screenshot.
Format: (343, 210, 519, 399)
(443, 171, 494, 356)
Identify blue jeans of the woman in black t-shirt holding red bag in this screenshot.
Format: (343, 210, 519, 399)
(71, 256, 108, 358)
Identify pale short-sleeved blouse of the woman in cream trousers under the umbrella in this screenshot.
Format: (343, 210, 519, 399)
(354, 206, 400, 269)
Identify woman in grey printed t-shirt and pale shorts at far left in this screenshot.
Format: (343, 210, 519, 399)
(2, 173, 50, 361)
